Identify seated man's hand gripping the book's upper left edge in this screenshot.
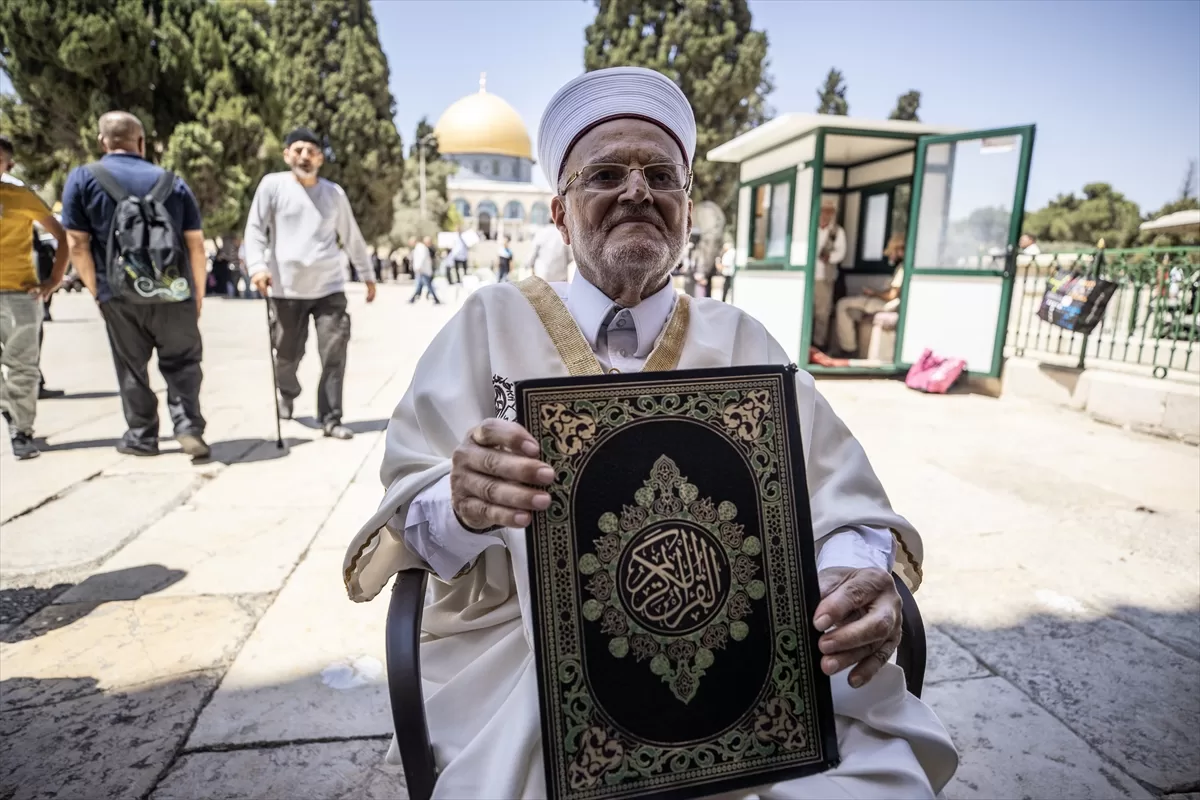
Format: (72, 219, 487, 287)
(450, 420, 554, 531)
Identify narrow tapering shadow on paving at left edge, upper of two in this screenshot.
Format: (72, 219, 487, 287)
(0, 564, 187, 642)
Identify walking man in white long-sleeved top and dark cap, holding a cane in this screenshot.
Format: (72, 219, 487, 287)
(245, 128, 376, 439)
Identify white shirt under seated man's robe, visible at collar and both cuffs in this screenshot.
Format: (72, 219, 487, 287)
(392, 272, 893, 581)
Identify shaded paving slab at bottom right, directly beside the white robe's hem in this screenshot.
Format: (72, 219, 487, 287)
(923, 678, 1152, 800)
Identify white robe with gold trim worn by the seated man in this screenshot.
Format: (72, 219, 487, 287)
(343, 284, 958, 799)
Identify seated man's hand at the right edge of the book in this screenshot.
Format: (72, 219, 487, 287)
(814, 567, 901, 688)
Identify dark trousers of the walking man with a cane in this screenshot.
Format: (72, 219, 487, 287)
(271, 291, 350, 425)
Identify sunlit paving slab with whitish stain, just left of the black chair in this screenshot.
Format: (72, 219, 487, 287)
(187, 548, 392, 748)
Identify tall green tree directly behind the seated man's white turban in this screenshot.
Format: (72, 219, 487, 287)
(583, 0, 772, 221)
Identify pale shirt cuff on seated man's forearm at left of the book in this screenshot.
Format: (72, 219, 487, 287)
(394, 475, 504, 581)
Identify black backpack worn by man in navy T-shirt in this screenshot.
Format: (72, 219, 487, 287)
(88, 164, 192, 303)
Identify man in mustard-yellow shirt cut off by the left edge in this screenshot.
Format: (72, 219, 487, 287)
(0, 137, 67, 461)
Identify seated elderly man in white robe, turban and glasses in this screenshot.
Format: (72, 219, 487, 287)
(343, 67, 958, 798)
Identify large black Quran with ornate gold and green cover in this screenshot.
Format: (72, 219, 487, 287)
(516, 367, 838, 800)
